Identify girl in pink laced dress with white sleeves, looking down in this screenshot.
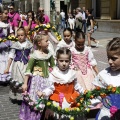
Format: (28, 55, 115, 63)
(71, 32, 98, 90)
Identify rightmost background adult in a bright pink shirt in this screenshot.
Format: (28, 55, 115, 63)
(38, 7, 50, 24)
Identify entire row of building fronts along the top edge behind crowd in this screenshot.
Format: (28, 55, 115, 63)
(3, 0, 120, 20)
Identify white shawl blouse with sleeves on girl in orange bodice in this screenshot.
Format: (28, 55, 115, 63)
(43, 67, 84, 96)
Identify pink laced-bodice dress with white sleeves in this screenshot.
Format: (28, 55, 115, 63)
(71, 46, 97, 90)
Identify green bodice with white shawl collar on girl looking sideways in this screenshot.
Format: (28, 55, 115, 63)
(25, 50, 55, 77)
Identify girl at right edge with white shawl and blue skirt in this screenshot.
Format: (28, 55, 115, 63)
(93, 37, 120, 120)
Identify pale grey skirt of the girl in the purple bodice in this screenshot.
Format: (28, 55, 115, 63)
(9, 61, 27, 100)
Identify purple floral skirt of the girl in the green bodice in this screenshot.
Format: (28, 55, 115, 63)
(19, 75, 49, 120)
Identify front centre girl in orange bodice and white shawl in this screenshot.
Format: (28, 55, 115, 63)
(38, 47, 84, 120)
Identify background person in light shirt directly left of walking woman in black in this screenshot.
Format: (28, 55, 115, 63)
(82, 7, 87, 33)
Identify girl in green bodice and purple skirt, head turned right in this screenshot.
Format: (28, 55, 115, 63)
(19, 31, 54, 120)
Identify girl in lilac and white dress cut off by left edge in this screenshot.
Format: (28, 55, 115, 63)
(0, 5, 13, 82)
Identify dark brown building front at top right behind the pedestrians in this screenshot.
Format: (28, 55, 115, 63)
(67, 0, 120, 20)
